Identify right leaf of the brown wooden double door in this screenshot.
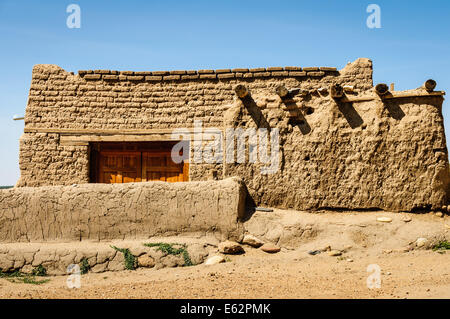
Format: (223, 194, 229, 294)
(142, 151, 189, 182)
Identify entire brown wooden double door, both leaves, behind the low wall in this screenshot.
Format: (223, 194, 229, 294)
(98, 151, 189, 184)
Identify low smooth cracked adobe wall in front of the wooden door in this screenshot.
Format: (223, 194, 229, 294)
(0, 178, 246, 242)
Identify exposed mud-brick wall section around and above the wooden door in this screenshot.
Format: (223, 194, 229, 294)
(17, 59, 372, 186)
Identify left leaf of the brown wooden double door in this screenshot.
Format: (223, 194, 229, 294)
(99, 151, 142, 184)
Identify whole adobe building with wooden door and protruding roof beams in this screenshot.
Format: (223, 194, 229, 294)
(17, 58, 450, 211)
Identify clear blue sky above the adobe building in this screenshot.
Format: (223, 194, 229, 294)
(0, 0, 450, 185)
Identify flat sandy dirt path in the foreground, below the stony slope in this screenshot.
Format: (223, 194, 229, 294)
(0, 249, 450, 298)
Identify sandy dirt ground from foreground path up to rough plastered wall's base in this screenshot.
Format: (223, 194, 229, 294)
(0, 213, 450, 299)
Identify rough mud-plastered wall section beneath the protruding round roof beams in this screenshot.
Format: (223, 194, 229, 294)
(226, 96, 450, 211)
